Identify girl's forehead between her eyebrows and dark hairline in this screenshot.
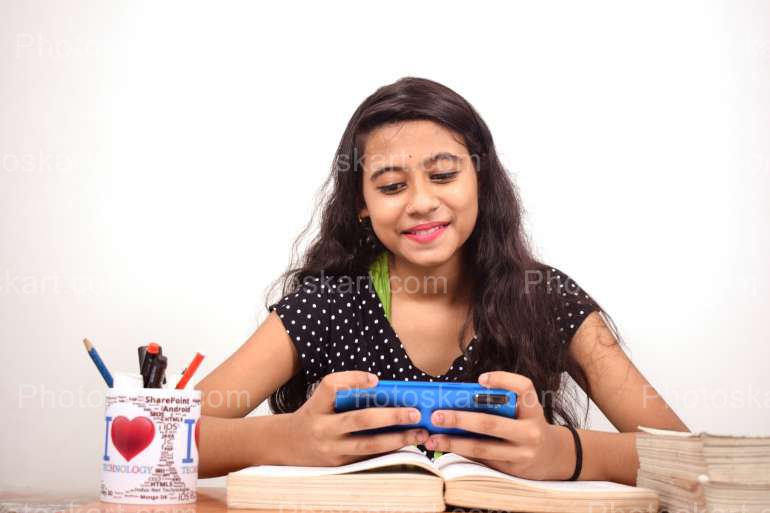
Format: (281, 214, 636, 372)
(363, 120, 468, 168)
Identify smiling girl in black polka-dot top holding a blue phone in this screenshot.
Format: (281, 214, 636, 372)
(197, 77, 687, 484)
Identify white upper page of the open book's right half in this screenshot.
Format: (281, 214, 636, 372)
(434, 453, 637, 493)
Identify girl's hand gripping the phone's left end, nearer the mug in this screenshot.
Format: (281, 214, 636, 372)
(285, 371, 428, 467)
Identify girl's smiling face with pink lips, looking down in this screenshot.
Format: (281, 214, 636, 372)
(359, 120, 478, 267)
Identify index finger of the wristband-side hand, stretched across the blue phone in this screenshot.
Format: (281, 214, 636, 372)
(430, 410, 540, 444)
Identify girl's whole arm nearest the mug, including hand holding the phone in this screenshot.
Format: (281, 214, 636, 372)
(196, 311, 438, 478)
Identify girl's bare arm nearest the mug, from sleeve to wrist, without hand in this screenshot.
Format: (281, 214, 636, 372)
(195, 311, 300, 478)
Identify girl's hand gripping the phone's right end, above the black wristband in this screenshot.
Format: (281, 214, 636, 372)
(425, 371, 575, 480)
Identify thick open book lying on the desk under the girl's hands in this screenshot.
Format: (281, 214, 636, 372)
(227, 445, 658, 513)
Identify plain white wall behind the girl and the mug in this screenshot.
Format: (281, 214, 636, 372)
(0, 1, 770, 494)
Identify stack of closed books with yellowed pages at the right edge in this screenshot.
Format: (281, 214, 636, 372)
(636, 426, 770, 513)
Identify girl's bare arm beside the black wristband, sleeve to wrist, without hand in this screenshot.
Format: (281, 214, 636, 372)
(559, 312, 689, 484)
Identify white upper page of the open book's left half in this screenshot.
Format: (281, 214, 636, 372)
(230, 445, 441, 477)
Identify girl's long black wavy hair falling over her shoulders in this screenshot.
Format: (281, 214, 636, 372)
(265, 77, 619, 427)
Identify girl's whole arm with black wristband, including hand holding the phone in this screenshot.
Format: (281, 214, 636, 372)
(425, 313, 687, 485)
